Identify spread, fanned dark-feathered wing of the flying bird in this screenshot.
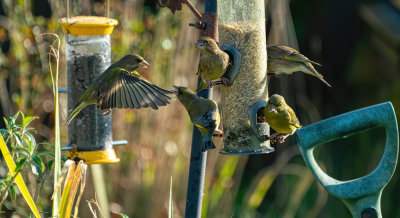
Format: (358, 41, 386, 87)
(97, 68, 173, 110)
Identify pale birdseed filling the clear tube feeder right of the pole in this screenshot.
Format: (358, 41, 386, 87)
(219, 22, 269, 152)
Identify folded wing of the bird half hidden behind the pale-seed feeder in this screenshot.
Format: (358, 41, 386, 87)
(267, 45, 321, 66)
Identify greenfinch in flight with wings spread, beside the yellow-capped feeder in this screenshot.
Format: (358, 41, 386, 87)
(66, 54, 173, 123)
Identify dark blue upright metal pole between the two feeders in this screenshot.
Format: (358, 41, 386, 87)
(185, 0, 218, 218)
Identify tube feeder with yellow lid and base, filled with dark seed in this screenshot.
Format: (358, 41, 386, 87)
(59, 16, 119, 164)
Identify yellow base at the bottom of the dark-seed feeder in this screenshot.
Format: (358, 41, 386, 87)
(67, 148, 119, 164)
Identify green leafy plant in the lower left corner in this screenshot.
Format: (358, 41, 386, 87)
(0, 112, 54, 214)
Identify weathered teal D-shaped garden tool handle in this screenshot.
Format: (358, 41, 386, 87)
(296, 102, 399, 218)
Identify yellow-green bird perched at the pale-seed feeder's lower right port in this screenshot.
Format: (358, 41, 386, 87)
(264, 94, 301, 143)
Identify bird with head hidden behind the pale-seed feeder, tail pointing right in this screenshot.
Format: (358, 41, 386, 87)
(267, 45, 331, 87)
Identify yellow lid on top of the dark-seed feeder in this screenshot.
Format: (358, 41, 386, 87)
(58, 16, 118, 35)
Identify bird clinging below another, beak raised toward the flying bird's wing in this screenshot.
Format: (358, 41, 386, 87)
(174, 86, 222, 152)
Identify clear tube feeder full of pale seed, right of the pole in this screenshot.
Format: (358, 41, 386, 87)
(218, 0, 274, 154)
